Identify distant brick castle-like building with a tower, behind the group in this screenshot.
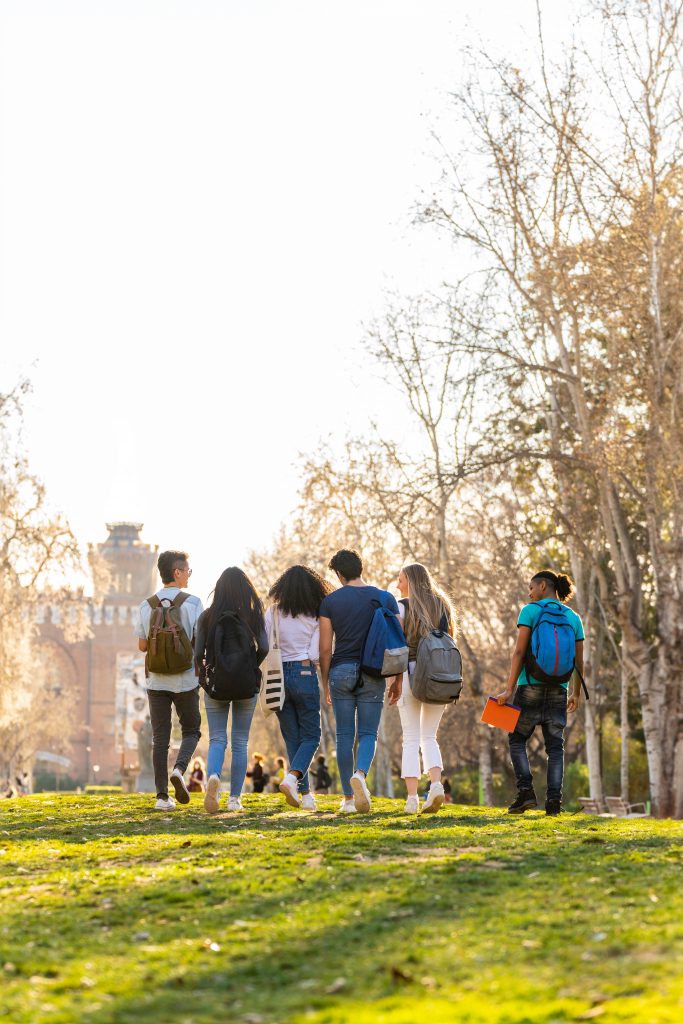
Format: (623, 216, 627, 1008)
(38, 522, 159, 783)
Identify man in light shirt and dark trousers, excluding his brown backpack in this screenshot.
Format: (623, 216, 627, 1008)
(135, 551, 203, 811)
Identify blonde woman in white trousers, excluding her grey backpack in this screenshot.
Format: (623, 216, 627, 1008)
(398, 562, 456, 814)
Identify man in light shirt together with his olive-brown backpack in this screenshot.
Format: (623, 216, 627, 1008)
(135, 551, 202, 811)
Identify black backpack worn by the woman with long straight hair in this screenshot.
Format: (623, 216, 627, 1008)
(200, 611, 261, 700)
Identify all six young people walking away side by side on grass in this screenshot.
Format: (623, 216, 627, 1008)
(136, 549, 583, 814)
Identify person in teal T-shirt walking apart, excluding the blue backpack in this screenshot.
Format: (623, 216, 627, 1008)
(496, 569, 585, 814)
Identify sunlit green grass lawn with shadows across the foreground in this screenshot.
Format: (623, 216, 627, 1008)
(0, 795, 683, 1024)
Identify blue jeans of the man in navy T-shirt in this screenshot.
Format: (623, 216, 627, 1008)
(330, 663, 386, 797)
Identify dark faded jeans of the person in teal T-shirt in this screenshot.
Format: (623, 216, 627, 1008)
(510, 683, 567, 800)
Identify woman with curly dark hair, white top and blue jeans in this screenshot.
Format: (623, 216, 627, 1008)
(265, 565, 333, 811)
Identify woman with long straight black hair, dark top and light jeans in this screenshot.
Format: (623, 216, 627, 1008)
(195, 566, 268, 814)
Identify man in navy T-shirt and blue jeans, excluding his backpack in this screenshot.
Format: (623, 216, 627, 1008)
(319, 548, 402, 813)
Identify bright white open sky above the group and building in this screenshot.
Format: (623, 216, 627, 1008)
(0, 0, 568, 598)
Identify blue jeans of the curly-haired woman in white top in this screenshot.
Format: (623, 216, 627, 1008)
(276, 662, 321, 793)
